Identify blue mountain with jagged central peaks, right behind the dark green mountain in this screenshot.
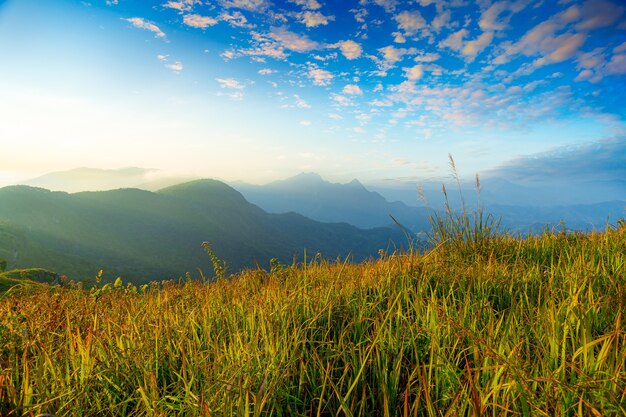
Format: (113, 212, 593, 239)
(231, 173, 430, 231)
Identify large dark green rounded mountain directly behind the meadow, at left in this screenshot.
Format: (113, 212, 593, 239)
(0, 180, 404, 282)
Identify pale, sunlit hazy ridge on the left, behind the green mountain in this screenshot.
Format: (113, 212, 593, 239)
(23, 167, 191, 193)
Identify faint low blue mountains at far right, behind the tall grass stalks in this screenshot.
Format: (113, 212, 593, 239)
(364, 178, 626, 234)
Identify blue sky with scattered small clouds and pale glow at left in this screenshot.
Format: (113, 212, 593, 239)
(0, 0, 626, 186)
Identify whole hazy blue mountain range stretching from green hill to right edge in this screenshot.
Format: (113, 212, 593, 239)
(232, 173, 626, 233)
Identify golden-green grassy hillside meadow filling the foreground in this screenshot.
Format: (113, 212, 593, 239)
(0, 222, 626, 416)
